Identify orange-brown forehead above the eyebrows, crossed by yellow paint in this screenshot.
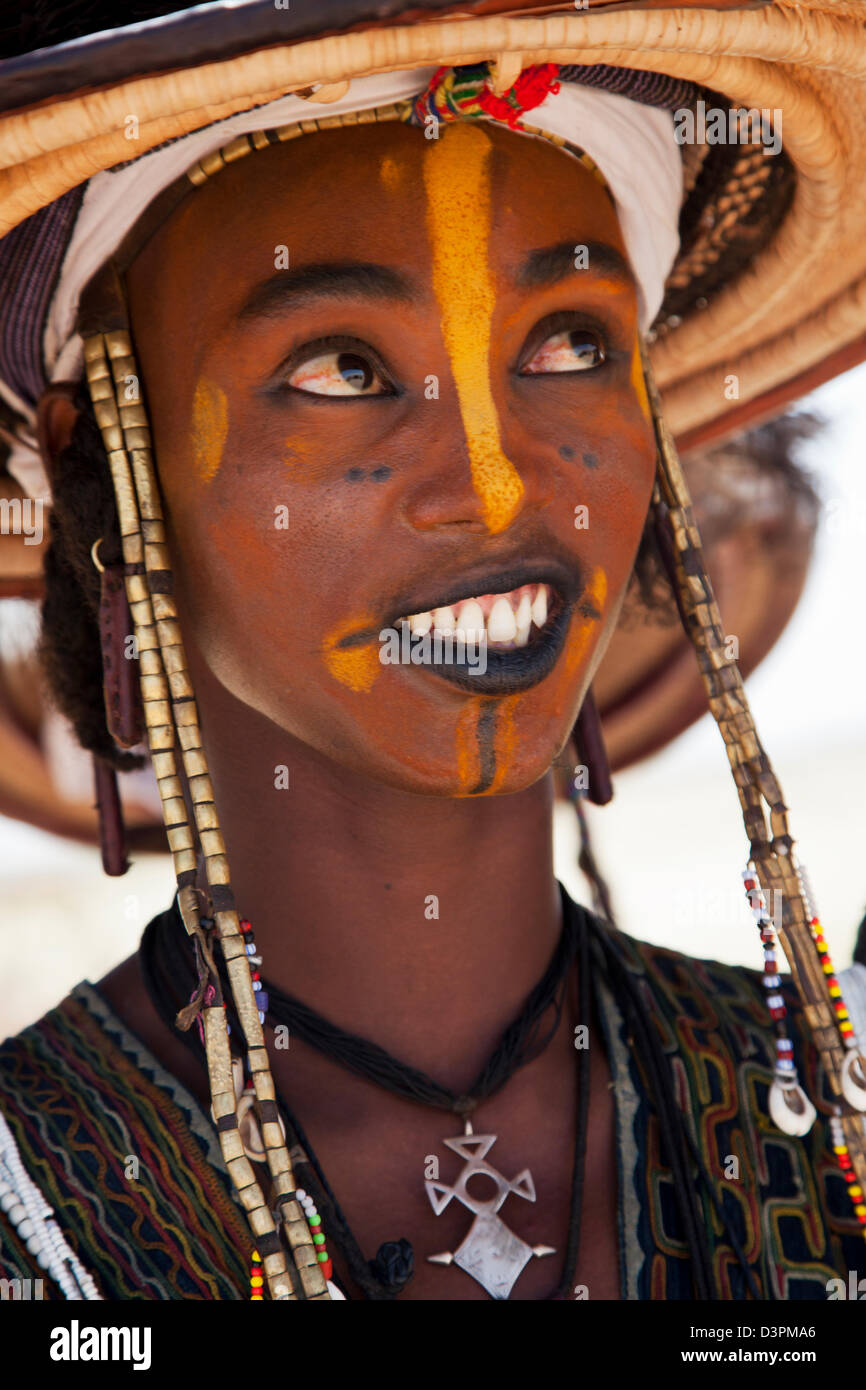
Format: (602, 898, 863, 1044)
(131, 121, 623, 304)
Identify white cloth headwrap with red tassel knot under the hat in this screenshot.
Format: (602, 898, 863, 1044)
(0, 64, 695, 498)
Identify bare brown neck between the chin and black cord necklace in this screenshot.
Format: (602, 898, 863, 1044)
(196, 658, 562, 1081)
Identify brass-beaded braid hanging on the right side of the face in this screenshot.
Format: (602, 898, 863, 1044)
(641, 345, 866, 1187)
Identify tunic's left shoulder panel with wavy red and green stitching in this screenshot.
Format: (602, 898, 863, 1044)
(0, 984, 249, 1300)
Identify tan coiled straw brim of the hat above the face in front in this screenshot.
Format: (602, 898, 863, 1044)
(0, 0, 866, 443)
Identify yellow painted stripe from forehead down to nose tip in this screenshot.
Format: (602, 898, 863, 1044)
(424, 122, 524, 532)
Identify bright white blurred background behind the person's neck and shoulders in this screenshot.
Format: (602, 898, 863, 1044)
(0, 366, 866, 1037)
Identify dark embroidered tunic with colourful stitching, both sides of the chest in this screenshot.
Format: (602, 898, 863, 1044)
(0, 906, 866, 1300)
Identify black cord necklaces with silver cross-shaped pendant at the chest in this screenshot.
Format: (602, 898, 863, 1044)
(140, 890, 591, 1298)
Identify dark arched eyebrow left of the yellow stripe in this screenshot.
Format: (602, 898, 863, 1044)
(236, 261, 417, 321)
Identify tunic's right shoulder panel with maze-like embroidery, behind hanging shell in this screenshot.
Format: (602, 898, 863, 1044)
(592, 929, 866, 1300)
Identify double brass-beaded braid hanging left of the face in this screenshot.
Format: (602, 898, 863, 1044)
(85, 329, 331, 1300)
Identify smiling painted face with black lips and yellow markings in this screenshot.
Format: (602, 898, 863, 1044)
(128, 122, 655, 796)
